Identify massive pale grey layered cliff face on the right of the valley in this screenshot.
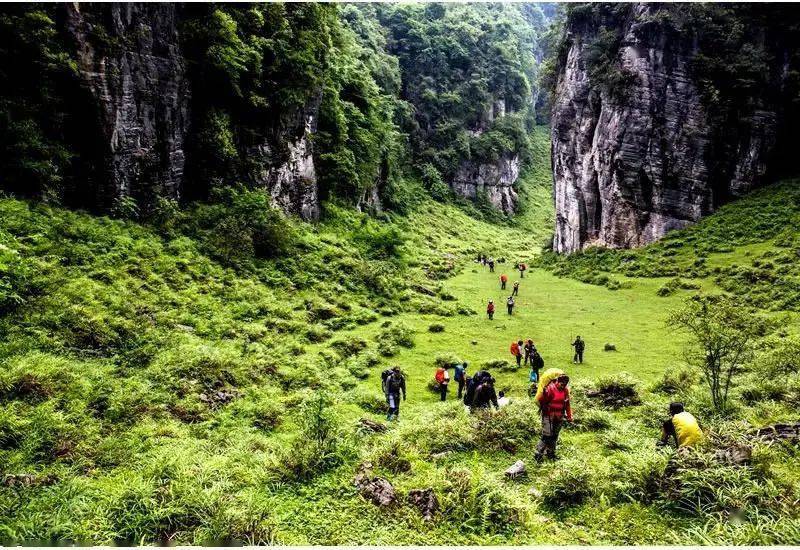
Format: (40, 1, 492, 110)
(551, 4, 796, 253)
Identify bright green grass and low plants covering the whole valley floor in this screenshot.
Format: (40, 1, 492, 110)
(0, 129, 800, 544)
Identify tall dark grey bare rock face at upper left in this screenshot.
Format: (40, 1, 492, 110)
(66, 3, 190, 211)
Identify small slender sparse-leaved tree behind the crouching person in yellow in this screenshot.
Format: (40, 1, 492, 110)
(667, 296, 765, 411)
